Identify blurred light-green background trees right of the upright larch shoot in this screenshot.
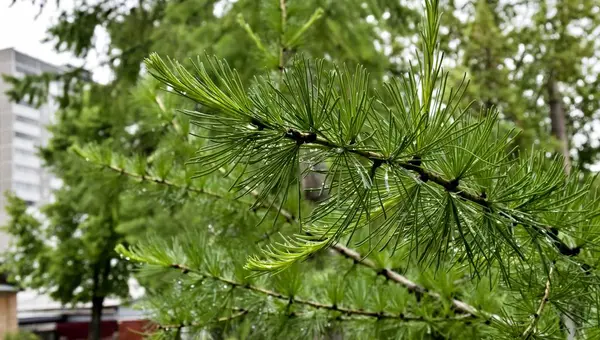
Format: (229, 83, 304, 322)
(438, 1, 600, 170)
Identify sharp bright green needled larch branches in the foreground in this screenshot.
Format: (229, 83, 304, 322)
(111, 1, 600, 338)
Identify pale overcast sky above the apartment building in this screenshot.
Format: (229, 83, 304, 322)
(0, 0, 108, 82)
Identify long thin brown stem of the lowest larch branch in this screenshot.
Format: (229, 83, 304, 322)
(169, 263, 474, 322)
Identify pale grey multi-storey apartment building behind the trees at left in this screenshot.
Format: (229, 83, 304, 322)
(0, 48, 61, 252)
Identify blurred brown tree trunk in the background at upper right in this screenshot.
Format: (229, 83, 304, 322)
(547, 71, 571, 174)
